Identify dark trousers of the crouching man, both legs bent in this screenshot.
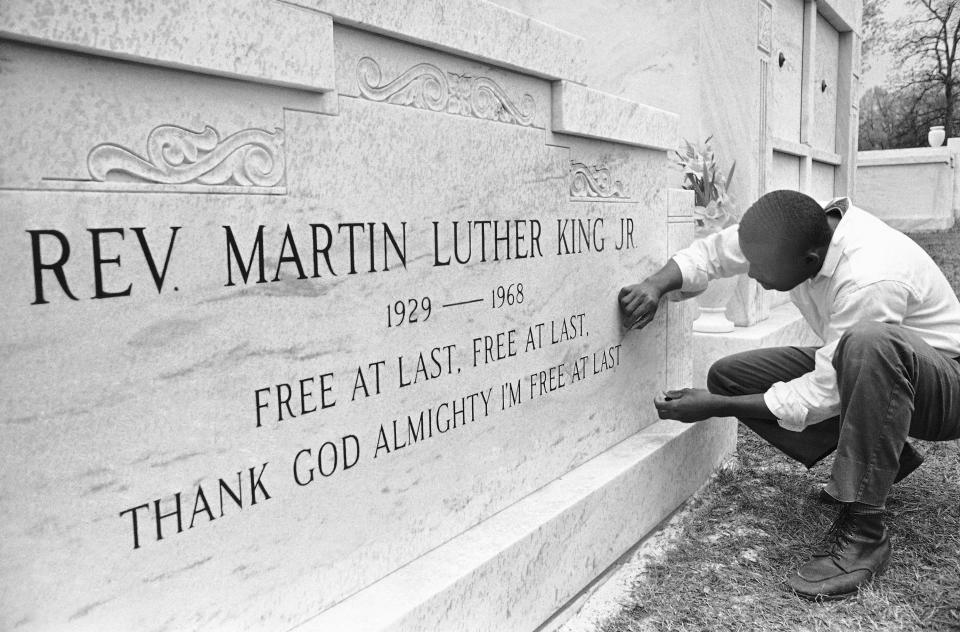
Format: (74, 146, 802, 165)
(707, 322, 960, 505)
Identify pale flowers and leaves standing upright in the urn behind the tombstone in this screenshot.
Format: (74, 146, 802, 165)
(673, 135, 740, 237)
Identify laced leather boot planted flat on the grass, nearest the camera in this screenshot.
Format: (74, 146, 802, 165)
(788, 504, 890, 599)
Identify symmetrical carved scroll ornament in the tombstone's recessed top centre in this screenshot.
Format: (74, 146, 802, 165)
(357, 57, 536, 125)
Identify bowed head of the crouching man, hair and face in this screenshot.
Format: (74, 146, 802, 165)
(740, 190, 833, 292)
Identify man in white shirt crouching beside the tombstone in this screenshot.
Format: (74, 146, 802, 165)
(619, 191, 960, 598)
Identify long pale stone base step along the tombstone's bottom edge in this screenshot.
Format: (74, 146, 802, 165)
(297, 420, 736, 632)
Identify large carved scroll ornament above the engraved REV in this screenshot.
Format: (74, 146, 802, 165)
(87, 125, 284, 187)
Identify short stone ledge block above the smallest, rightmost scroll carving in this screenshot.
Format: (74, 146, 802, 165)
(553, 81, 680, 149)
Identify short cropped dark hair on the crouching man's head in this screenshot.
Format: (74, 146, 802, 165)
(740, 189, 831, 252)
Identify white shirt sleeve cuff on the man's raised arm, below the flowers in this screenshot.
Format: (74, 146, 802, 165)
(672, 225, 750, 295)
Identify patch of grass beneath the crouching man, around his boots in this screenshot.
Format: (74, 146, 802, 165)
(599, 425, 960, 632)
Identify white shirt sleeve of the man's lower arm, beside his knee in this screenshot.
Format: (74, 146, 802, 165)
(763, 281, 912, 432)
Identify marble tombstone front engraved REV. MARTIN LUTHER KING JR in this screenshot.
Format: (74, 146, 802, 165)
(0, 1, 736, 630)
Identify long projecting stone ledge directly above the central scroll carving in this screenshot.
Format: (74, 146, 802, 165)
(286, 0, 586, 81)
